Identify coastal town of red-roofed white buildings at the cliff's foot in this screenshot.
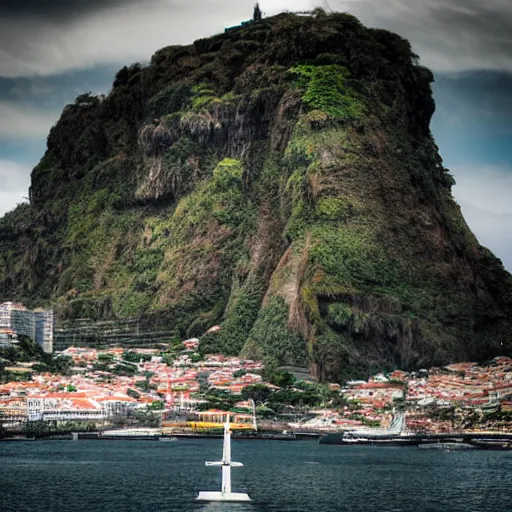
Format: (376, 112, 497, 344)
(0, 316, 512, 435)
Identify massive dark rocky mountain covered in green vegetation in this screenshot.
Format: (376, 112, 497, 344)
(0, 11, 512, 379)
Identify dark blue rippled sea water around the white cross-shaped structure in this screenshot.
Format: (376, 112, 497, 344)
(0, 439, 512, 512)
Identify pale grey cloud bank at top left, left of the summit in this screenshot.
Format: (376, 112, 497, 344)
(0, 0, 253, 77)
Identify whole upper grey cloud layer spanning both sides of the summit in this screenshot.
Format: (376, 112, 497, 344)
(0, 0, 512, 77)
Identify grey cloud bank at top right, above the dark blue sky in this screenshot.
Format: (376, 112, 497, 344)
(330, 0, 512, 72)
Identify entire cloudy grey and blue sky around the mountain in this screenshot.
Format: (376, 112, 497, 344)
(0, 0, 512, 270)
